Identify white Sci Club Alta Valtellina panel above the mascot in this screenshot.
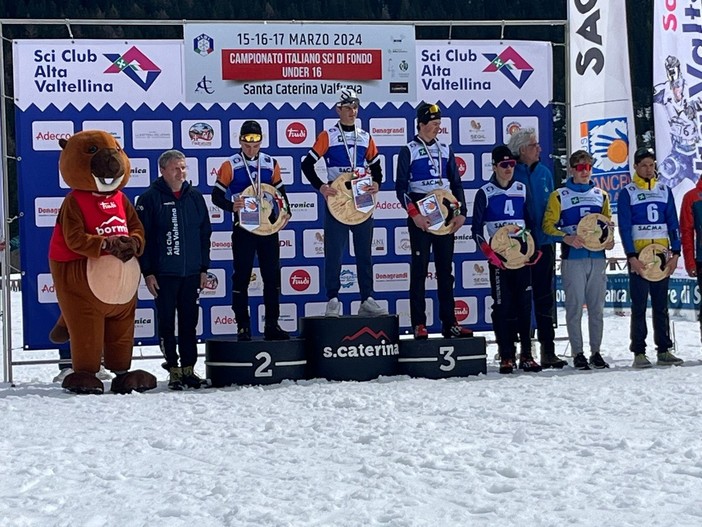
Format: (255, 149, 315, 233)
(12, 40, 183, 109)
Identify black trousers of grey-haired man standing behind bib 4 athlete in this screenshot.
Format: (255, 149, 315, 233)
(531, 244, 556, 350)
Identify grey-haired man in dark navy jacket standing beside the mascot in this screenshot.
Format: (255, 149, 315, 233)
(136, 150, 212, 390)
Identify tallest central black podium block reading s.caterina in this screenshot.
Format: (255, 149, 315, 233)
(300, 315, 400, 381)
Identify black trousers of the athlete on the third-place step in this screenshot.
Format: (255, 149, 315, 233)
(407, 218, 456, 328)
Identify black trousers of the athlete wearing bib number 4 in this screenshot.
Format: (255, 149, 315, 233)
(489, 264, 531, 359)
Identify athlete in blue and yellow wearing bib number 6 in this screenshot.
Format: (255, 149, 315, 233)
(617, 148, 683, 368)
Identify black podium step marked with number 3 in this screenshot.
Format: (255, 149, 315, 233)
(398, 337, 487, 379)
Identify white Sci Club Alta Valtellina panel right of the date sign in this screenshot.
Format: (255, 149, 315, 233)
(417, 40, 553, 106)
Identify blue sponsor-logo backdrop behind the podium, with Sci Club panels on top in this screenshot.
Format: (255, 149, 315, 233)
(9, 38, 552, 349)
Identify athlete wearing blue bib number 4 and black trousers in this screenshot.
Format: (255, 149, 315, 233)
(471, 145, 541, 373)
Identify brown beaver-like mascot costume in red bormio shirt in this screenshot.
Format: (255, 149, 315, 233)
(49, 130, 156, 394)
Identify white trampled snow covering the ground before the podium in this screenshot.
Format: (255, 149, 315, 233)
(0, 293, 702, 527)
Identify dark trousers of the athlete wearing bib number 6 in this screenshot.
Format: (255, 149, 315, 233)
(629, 273, 673, 353)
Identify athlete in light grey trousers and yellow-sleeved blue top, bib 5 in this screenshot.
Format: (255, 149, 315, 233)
(542, 150, 614, 370)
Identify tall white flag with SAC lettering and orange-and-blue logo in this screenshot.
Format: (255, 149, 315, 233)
(568, 0, 636, 212)
